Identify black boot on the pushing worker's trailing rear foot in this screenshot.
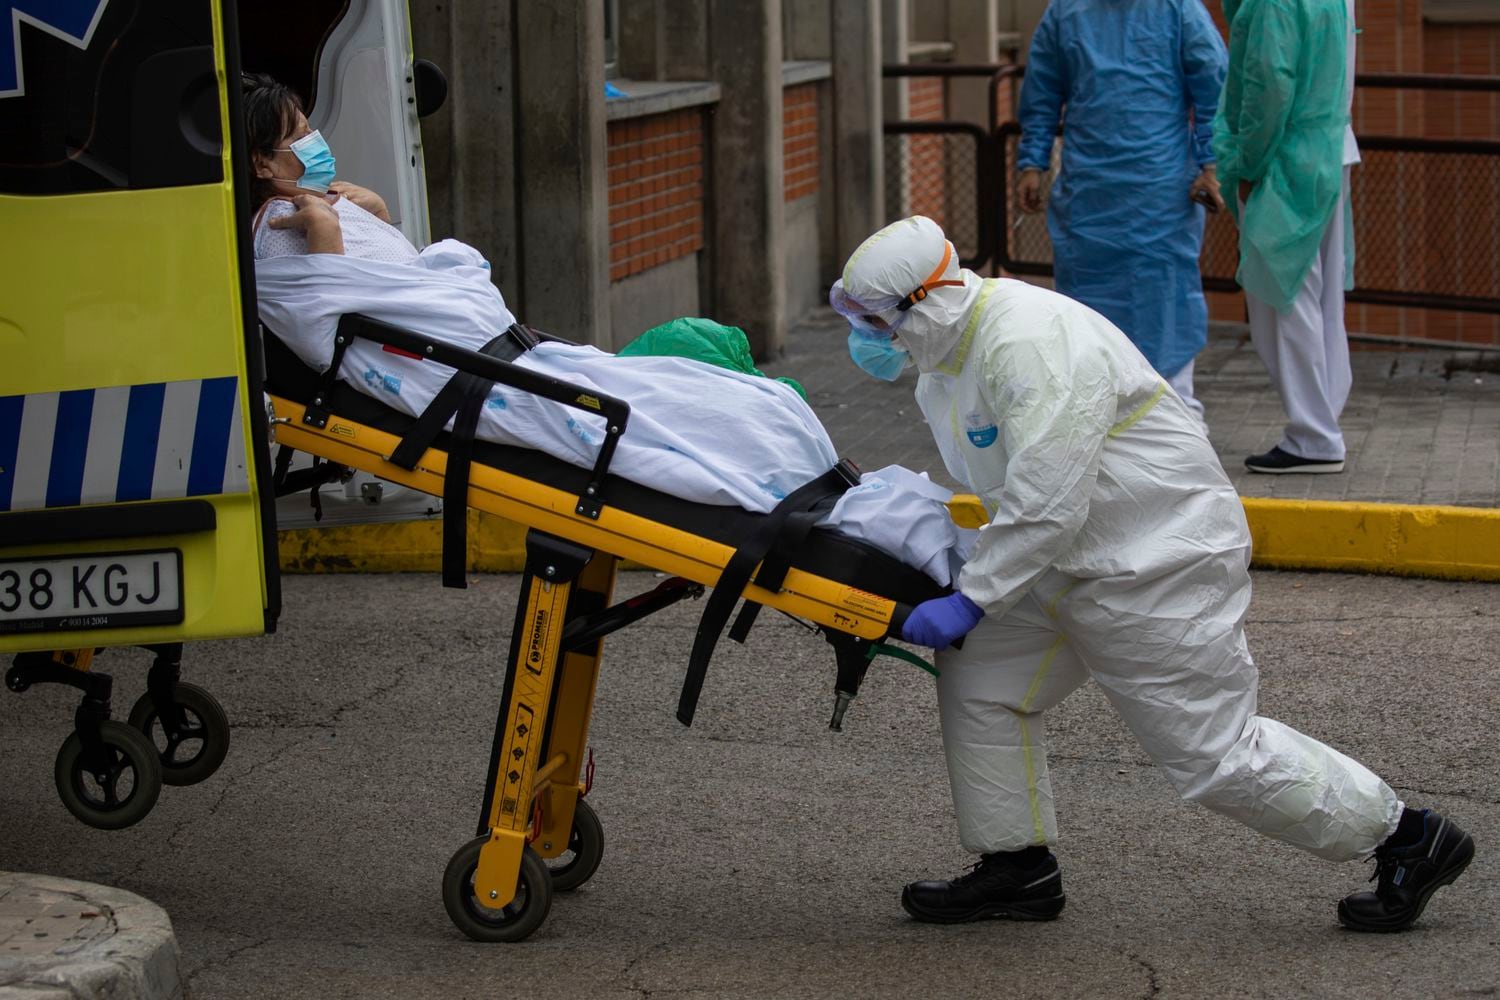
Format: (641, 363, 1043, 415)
(1338, 810, 1475, 931)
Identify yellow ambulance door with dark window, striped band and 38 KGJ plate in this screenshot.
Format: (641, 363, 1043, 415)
(0, 0, 281, 652)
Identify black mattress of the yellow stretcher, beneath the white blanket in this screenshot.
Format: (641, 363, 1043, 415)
(266, 333, 948, 604)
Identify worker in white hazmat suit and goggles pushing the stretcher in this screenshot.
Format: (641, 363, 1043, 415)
(830, 216, 1473, 930)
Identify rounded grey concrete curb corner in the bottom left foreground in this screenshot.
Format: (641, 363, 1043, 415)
(0, 871, 183, 1000)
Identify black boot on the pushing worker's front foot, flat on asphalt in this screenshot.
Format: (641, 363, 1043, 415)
(902, 846, 1067, 924)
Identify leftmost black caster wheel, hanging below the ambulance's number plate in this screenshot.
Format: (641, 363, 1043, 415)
(53, 721, 162, 831)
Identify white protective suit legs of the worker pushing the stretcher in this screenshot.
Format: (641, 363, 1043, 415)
(938, 552, 1403, 861)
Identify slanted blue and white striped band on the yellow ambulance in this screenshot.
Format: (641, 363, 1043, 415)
(0, 375, 249, 511)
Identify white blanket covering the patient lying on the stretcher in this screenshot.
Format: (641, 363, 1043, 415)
(255, 240, 975, 585)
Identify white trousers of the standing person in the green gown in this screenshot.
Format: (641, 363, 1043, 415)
(1245, 166, 1353, 462)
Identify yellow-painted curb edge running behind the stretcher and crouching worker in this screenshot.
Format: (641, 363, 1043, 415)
(281, 495, 1500, 580)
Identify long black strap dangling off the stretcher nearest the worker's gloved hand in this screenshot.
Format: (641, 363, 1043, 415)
(677, 462, 860, 726)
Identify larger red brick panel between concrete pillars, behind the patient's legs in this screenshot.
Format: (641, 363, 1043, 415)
(609, 108, 704, 282)
